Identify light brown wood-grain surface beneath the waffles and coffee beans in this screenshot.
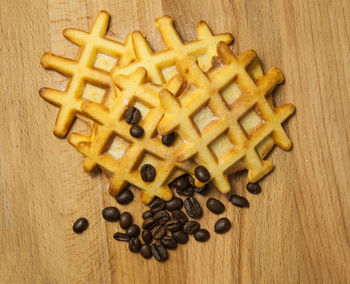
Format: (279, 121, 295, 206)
(0, 0, 350, 284)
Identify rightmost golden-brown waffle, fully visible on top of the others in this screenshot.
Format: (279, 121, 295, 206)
(158, 42, 295, 193)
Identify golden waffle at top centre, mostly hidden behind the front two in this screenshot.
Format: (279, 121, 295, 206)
(112, 16, 233, 84)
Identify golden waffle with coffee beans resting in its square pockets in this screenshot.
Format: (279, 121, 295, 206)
(68, 68, 195, 203)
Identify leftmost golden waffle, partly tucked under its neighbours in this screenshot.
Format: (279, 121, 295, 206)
(39, 11, 134, 138)
